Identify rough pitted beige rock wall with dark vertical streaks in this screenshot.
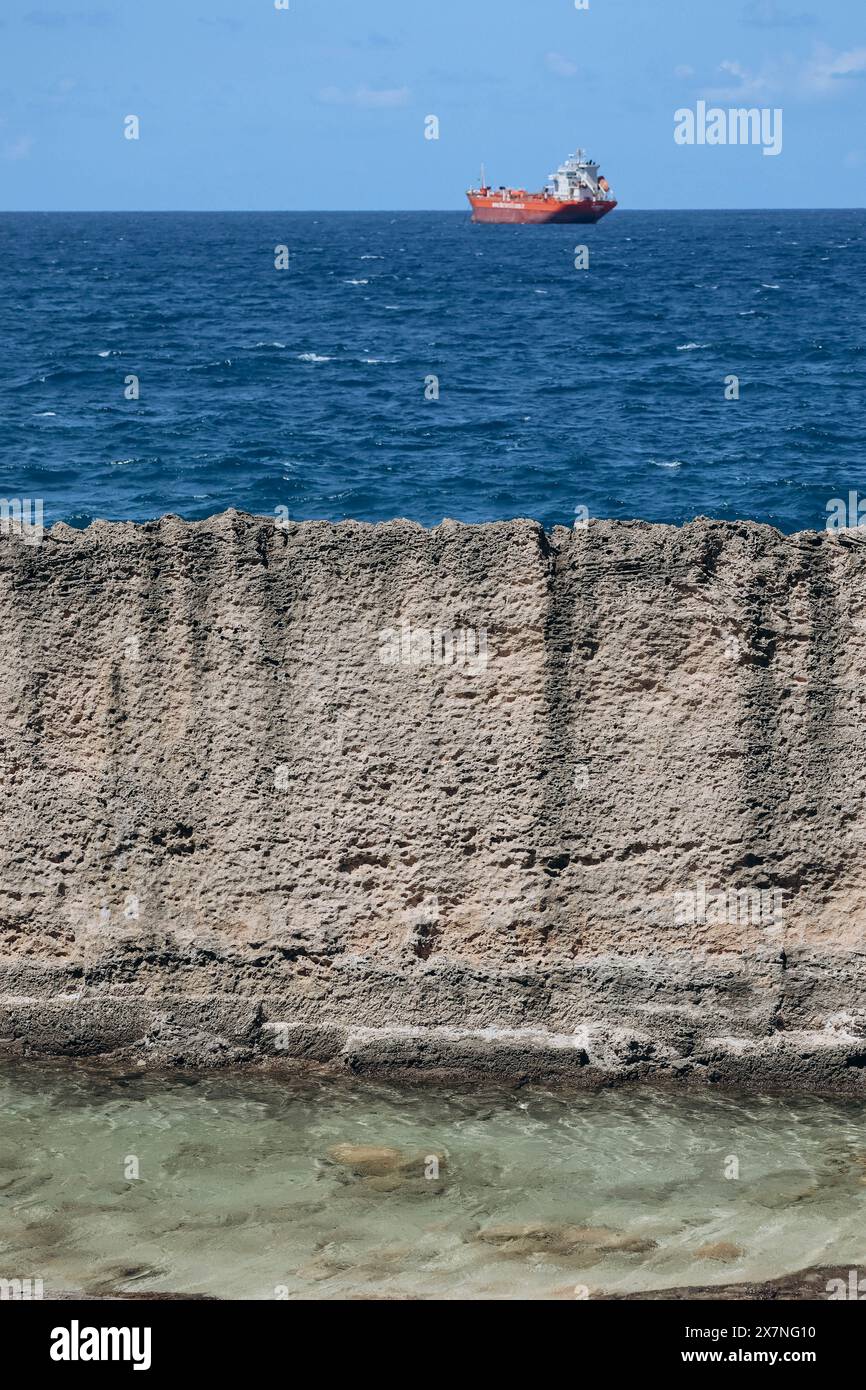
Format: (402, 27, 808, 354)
(0, 512, 866, 1094)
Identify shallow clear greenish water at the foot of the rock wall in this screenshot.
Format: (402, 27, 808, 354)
(0, 1063, 866, 1300)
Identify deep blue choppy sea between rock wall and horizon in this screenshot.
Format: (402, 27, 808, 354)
(0, 210, 866, 531)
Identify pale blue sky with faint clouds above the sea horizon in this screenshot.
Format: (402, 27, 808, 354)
(0, 0, 866, 211)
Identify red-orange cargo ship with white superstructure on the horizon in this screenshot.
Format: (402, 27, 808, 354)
(466, 150, 616, 222)
